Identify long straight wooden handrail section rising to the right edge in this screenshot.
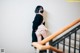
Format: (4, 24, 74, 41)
(40, 18, 80, 44)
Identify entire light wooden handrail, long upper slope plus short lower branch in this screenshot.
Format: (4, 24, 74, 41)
(32, 18, 80, 53)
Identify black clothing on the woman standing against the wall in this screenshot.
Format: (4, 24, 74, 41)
(32, 14, 45, 42)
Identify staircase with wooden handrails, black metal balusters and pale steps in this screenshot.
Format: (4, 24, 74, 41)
(32, 18, 80, 53)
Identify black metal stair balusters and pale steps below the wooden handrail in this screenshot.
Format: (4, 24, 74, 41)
(49, 25, 80, 53)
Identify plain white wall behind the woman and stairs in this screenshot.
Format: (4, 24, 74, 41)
(0, 0, 80, 53)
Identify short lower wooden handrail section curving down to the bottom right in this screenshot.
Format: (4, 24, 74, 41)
(32, 42, 63, 53)
